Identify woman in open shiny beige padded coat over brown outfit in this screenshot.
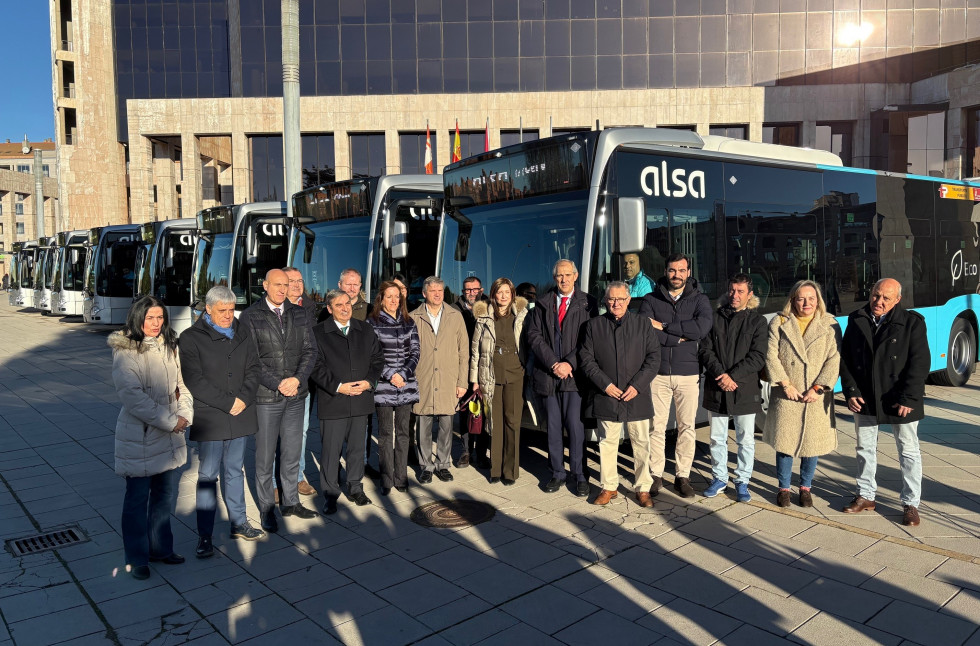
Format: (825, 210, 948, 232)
(470, 278, 528, 485)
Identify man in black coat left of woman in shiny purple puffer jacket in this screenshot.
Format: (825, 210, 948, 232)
(312, 290, 384, 515)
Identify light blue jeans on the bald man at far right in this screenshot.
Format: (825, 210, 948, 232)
(854, 415, 922, 507)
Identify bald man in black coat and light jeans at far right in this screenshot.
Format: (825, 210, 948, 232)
(840, 278, 930, 526)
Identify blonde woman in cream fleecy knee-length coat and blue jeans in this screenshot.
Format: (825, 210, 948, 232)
(762, 280, 840, 507)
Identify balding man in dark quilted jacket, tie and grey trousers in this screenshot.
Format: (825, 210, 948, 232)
(240, 269, 317, 533)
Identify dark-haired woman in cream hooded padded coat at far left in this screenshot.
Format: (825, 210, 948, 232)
(108, 296, 194, 579)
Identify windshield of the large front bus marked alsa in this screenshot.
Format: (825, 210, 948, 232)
(439, 191, 588, 298)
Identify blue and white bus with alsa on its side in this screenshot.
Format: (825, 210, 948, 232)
(438, 128, 980, 385)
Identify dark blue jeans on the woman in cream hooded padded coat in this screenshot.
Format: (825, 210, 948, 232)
(122, 469, 178, 567)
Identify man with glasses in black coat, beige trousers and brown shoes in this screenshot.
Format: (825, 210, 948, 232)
(579, 281, 660, 507)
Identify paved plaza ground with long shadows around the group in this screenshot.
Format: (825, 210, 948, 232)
(0, 299, 980, 646)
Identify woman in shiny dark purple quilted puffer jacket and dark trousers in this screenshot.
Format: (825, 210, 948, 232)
(368, 280, 419, 496)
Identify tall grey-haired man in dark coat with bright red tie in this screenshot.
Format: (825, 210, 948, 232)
(526, 259, 599, 497)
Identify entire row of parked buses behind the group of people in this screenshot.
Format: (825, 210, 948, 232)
(10, 128, 980, 385)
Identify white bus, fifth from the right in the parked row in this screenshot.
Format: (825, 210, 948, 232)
(82, 224, 141, 325)
